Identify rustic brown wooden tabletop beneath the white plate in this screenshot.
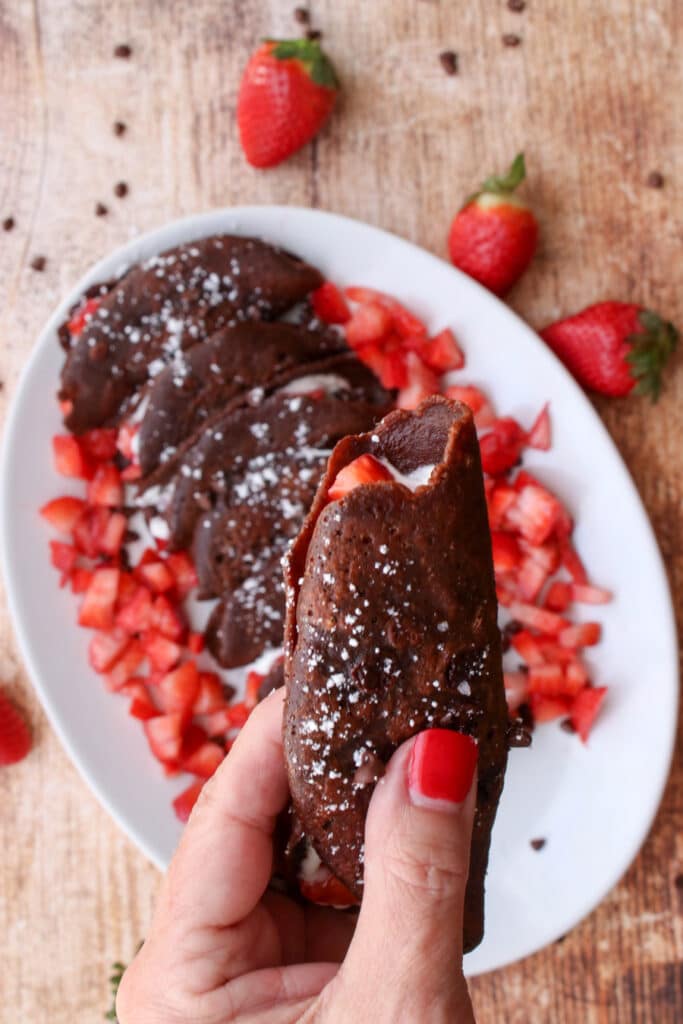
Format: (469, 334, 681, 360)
(0, 0, 683, 1024)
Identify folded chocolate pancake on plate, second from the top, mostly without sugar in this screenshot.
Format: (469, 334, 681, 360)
(138, 321, 346, 479)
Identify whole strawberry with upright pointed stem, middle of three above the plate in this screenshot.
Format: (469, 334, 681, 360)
(449, 153, 539, 295)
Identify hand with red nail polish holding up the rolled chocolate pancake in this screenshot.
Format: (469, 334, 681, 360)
(117, 690, 476, 1024)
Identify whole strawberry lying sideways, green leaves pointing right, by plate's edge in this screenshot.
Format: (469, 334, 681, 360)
(541, 302, 678, 401)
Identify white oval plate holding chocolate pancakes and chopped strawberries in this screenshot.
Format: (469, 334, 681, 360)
(0, 207, 678, 975)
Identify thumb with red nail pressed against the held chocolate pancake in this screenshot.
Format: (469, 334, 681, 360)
(344, 729, 477, 1020)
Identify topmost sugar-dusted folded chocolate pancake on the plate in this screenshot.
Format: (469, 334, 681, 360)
(59, 234, 322, 433)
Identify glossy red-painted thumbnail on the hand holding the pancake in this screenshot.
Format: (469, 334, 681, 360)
(408, 729, 478, 810)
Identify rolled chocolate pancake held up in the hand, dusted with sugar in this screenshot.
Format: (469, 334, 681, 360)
(284, 397, 508, 949)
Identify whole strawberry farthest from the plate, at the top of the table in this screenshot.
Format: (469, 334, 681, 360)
(238, 39, 339, 167)
